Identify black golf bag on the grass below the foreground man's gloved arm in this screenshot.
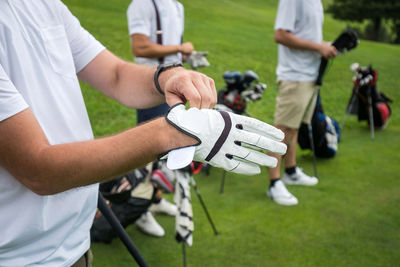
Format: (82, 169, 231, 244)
(90, 168, 152, 243)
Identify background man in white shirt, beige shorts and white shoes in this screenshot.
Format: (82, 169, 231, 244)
(267, 0, 337, 206)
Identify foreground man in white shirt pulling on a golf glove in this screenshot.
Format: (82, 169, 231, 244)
(0, 0, 286, 267)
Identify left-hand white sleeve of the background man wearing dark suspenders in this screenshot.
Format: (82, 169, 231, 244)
(126, 0, 153, 36)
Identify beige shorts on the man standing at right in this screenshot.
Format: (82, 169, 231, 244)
(274, 81, 317, 129)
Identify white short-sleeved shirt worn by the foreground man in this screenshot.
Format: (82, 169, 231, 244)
(0, 0, 104, 267)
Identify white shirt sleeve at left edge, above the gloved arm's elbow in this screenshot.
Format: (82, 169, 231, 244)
(0, 64, 28, 121)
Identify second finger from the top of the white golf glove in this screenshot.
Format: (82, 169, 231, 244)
(237, 132, 287, 155)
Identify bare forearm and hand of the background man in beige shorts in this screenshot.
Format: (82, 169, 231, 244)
(274, 29, 337, 58)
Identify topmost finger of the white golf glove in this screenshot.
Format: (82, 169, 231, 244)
(234, 114, 285, 141)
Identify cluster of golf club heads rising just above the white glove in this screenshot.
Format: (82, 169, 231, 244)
(216, 70, 267, 115)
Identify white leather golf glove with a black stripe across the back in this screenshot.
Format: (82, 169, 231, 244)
(166, 104, 286, 175)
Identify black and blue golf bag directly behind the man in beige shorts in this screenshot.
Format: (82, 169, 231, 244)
(298, 95, 340, 158)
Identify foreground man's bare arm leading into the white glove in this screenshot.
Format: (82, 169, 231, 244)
(0, 109, 196, 195)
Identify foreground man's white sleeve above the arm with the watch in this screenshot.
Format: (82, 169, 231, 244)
(58, 1, 105, 73)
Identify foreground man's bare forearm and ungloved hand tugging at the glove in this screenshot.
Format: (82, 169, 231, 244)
(78, 50, 217, 108)
